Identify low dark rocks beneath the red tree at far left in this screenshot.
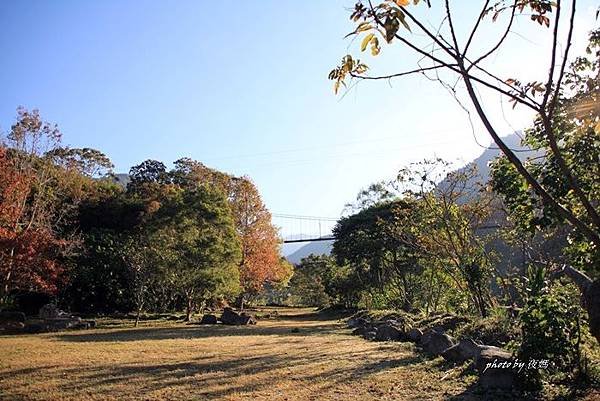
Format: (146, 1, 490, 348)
(0, 305, 96, 334)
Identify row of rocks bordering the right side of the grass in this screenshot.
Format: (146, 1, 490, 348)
(347, 317, 516, 388)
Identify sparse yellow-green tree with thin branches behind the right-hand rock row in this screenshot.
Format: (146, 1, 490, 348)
(396, 160, 495, 317)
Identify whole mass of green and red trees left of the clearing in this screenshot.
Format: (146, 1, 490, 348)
(0, 109, 292, 318)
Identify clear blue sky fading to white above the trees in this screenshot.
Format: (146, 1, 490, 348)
(0, 0, 596, 227)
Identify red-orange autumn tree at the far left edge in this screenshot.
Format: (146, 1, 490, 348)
(0, 108, 110, 302)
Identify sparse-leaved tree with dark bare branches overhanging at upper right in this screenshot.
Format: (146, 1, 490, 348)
(329, 0, 600, 340)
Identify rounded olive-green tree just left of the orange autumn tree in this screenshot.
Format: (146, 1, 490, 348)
(151, 185, 241, 320)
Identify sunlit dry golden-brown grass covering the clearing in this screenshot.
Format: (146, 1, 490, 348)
(0, 310, 598, 401)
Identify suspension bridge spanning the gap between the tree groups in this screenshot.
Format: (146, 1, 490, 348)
(272, 213, 338, 244)
